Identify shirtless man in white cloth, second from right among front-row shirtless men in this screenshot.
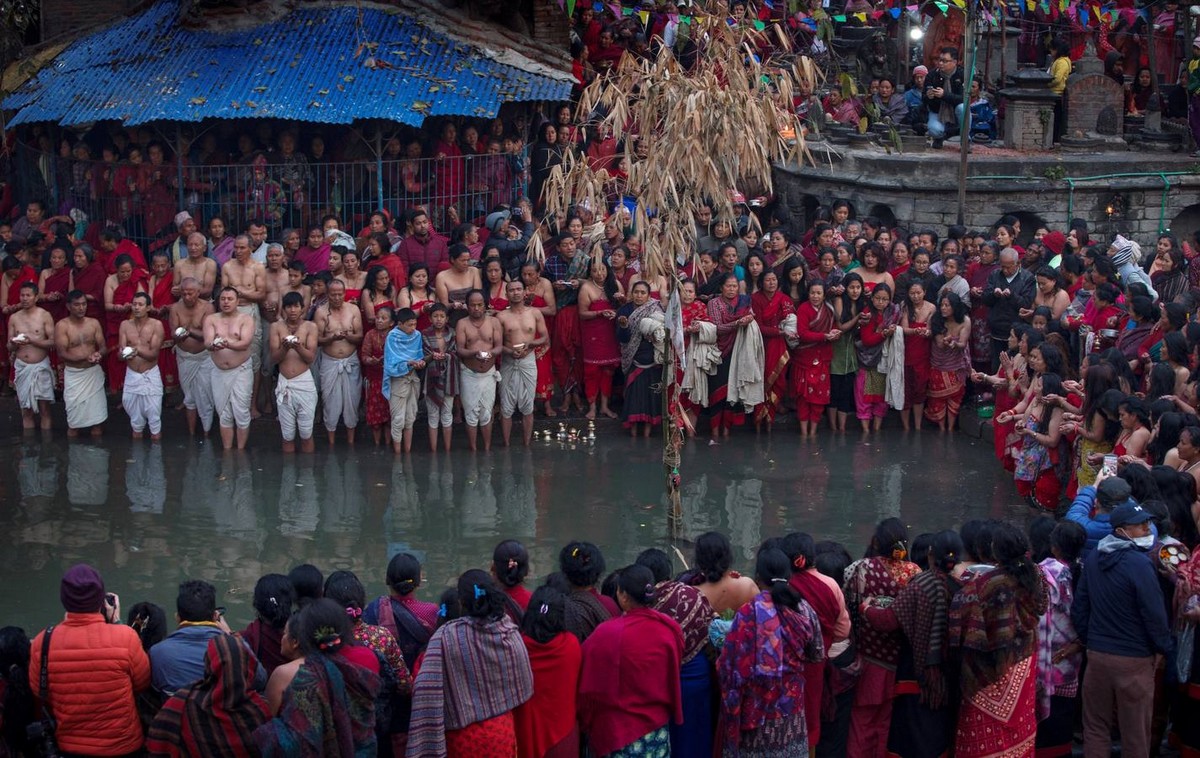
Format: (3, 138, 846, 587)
(453, 290, 501, 451)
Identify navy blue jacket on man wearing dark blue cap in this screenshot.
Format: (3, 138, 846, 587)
(1070, 535, 1171, 658)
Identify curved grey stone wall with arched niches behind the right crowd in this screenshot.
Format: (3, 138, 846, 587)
(774, 150, 1200, 245)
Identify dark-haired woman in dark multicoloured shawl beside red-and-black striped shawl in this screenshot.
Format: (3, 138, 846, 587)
(254, 598, 379, 758)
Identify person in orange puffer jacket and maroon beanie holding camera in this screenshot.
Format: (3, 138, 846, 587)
(29, 564, 150, 756)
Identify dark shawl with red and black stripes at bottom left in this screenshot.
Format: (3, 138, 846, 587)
(146, 634, 270, 758)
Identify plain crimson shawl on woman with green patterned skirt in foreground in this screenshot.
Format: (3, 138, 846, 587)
(578, 608, 683, 756)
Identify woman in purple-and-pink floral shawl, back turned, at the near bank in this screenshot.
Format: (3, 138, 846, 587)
(716, 543, 824, 758)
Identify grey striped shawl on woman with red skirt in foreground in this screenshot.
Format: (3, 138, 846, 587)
(407, 616, 533, 757)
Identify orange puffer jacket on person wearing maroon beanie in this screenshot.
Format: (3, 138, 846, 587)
(29, 613, 150, 756)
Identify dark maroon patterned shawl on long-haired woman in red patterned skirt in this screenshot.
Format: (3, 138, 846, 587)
(950, 569, 1049, 698)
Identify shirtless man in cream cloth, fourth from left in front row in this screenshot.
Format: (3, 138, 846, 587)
(168, 278, 212, 437)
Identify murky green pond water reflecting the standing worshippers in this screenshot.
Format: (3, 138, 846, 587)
(0, 428, 1025, 631)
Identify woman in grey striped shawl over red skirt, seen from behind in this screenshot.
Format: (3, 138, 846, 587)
(407, 569, 533, 758)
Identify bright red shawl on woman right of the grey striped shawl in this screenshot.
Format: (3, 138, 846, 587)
(512, 628, 583, 758)
